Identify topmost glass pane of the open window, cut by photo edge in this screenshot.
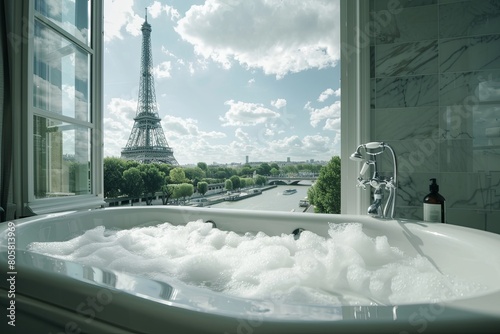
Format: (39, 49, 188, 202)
(35, 0, 92, 45)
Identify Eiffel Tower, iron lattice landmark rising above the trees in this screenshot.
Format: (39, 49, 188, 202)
(121, 9, 179, 166)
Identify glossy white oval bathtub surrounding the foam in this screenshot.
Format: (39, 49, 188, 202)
(0, 206, 500, 334)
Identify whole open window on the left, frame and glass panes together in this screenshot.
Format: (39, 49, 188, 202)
(4, 0, 104, 217)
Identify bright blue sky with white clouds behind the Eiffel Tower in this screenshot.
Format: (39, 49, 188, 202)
(103, 0, 340, 165)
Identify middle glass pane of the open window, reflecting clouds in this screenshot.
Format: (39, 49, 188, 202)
(33, 21, 90, 121)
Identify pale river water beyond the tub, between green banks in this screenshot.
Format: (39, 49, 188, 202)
(211, 185, 310, 212)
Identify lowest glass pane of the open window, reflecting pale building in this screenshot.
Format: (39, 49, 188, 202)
(33, 116, 91, 198)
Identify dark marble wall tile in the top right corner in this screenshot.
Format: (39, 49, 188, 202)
(439, 0, 500, 38)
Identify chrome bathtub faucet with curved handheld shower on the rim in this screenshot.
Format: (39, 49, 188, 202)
(350, 142, 398, 218)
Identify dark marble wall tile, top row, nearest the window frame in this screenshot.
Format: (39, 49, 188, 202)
(372, 5, 438, 44)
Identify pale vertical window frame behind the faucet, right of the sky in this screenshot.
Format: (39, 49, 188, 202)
(340, 0, 371, 215)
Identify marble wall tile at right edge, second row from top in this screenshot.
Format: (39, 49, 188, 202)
(439, 34, 500, 73)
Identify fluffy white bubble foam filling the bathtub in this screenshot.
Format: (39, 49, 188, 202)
(28, 221, 481, 305)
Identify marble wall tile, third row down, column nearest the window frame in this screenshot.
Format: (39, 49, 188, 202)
(376, 75, 438, 108)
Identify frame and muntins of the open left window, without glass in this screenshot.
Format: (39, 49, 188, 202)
(13, 1, 105, 217)
